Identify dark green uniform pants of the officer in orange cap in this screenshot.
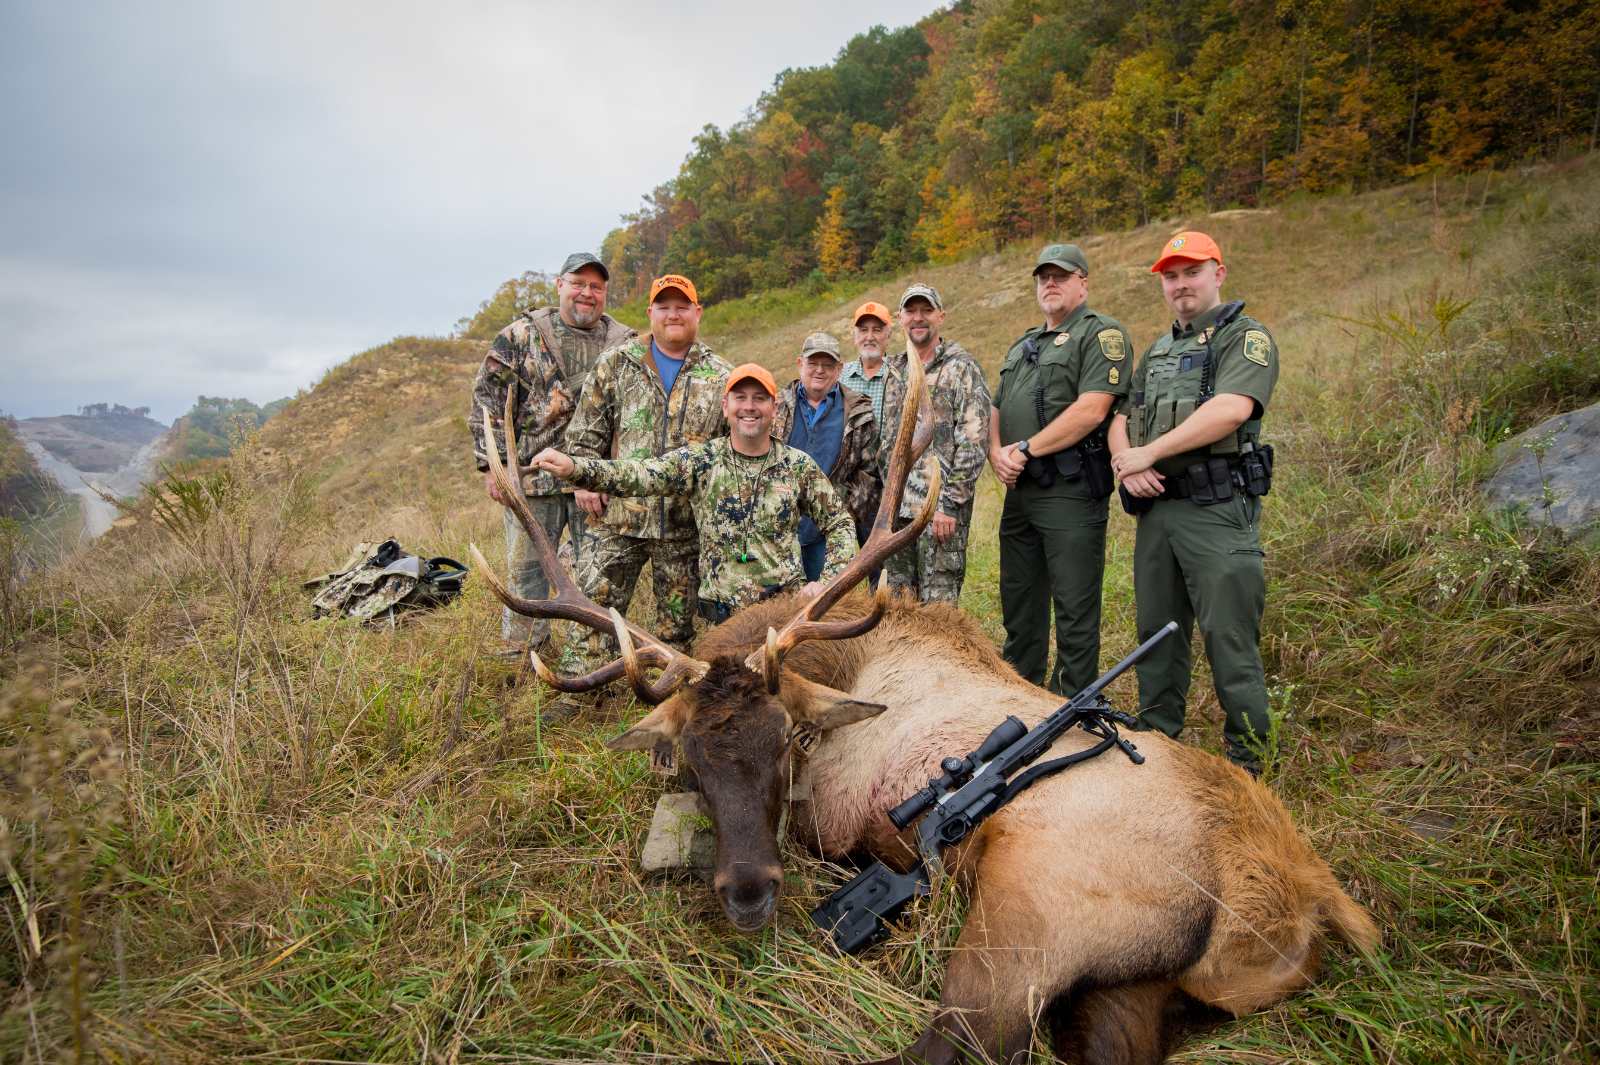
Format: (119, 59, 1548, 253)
(1133, 496, 1269, 763)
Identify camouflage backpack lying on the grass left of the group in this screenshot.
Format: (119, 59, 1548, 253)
(306, 540, 467, 622)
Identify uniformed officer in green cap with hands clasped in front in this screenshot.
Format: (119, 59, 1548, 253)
(989, 245, 1133, 696)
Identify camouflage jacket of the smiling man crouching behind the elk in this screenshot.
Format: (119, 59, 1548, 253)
(571, 437, 856, 608)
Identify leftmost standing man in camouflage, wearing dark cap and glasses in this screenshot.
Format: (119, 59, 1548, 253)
(467, 251, 634, 643)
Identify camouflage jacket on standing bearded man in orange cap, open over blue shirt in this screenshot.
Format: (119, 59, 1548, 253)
(565, 334, 733, 540)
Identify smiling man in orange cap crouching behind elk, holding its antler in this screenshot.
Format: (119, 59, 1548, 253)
(534, 363, 856, 622)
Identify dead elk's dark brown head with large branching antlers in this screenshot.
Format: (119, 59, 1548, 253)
(472, 355, 939, 932)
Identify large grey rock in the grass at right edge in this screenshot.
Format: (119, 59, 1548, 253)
(1483, 403, 1600, 540)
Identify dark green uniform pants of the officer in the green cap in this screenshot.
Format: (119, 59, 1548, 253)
(1000, 477, 1106, 696)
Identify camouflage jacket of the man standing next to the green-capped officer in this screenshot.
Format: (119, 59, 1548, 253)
(878, 341, 992, 518)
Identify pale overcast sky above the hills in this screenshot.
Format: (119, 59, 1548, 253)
(0, 0, 938, 421)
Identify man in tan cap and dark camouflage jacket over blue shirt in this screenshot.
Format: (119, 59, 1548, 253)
(773, 333, 883, 562)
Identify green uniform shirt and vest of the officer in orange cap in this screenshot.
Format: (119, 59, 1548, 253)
(1118, 304, 1278, 477)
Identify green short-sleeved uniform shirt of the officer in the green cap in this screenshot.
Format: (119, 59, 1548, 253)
(995, 304, 1133, 445)
